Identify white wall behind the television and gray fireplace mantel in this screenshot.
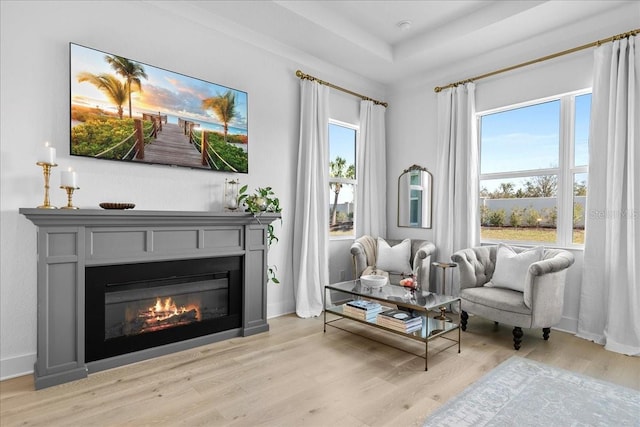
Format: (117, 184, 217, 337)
(0, 0, 384, 378)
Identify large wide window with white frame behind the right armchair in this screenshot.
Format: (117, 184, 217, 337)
(478, 92, 591, 246)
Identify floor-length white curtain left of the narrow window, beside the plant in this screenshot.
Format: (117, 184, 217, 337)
(293, 80, 329, 318)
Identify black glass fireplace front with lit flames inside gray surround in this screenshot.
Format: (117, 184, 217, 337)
(85, 257, 242, 362)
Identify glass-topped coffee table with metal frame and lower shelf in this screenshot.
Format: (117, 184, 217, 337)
(324, 280, 462, 371)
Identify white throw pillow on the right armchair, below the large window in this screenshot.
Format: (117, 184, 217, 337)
(486, 243, 544, 292)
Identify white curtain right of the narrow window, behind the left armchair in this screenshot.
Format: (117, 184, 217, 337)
(356, 101, 387, 238)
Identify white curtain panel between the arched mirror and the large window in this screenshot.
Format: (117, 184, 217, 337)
(434, 83, 480, 295)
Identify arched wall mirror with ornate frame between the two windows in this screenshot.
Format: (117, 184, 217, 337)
(398, 165, 432, 228)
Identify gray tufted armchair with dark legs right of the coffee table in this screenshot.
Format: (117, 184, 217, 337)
(451, 246, 574, 350)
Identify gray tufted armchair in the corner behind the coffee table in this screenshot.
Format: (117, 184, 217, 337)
(351, 235, 436, 287)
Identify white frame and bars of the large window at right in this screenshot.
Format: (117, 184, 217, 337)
(475, 88, 592, 249)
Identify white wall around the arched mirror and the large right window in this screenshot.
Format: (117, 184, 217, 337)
(387, 2, 640, 338)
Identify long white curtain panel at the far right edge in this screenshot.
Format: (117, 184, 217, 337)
(578, 36, 640, 356)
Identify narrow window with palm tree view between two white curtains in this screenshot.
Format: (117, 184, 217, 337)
(329, 120, 358, 238)
